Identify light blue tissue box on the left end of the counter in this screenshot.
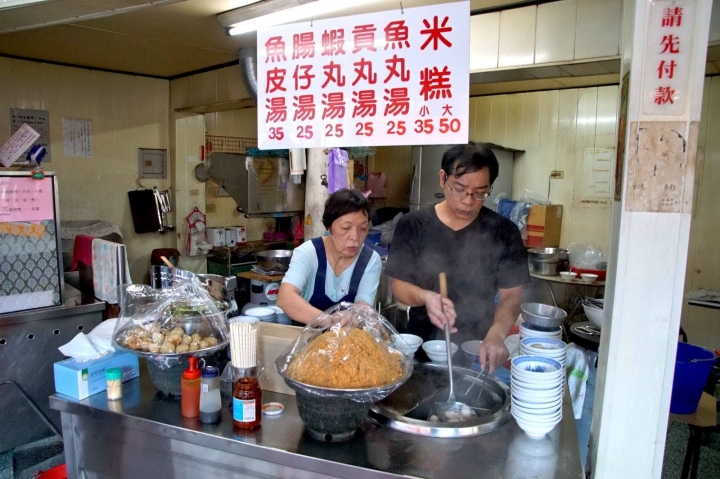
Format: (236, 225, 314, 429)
(53, 351, 140, 399)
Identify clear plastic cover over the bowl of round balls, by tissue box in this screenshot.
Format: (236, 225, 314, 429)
(113, 278, 230, 369)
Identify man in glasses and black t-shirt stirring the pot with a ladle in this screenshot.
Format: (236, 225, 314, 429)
(386, 142, 530, 372)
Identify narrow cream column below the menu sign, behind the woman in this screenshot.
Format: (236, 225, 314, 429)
(305, 148, 330, 241)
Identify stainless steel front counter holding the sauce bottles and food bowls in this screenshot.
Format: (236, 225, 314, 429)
(50, 374, 584, 479)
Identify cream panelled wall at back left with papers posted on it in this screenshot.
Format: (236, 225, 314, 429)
(0, 58, 174, 282)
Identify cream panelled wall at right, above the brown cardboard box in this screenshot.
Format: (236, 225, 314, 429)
(470, 86, 618, 252)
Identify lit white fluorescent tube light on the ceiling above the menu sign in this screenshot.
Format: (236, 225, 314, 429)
(225, 0, 386, 35)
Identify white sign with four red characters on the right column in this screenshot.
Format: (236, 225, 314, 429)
(642, 0, 695, 115)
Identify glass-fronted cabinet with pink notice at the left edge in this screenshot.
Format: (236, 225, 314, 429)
(0, 171, 65, 315)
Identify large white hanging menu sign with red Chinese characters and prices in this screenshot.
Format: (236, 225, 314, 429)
(257, 1, 470, 149)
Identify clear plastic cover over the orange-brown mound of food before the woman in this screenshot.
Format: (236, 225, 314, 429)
(275, 302, 413, 403)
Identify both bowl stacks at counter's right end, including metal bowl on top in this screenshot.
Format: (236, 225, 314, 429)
(510, 303, 567, 438)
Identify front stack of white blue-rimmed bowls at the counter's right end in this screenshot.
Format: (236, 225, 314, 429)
(510, 356, 565, 438)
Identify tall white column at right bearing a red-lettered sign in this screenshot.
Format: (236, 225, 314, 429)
(591, 0, 713, 479)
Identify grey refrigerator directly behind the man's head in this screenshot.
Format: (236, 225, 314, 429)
(410, 145, 513, 211)
